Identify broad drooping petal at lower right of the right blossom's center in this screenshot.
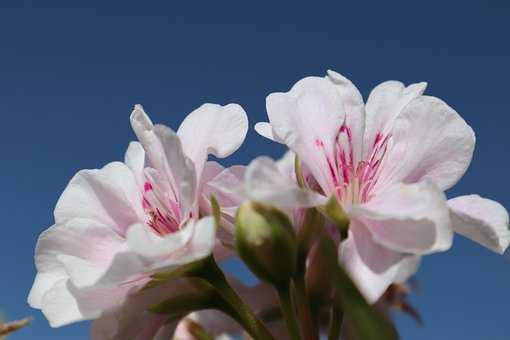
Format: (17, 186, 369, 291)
(349, 182, 453, 255)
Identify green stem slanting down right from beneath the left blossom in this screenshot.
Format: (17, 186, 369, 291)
(196, 257, 274, 340)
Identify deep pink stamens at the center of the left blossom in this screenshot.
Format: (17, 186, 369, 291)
(142, 181, 182, 235)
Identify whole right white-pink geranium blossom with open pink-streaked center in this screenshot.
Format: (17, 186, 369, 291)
(246, 71, 510, 301)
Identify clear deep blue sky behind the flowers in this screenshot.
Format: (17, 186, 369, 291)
(0, 0, 510, 340)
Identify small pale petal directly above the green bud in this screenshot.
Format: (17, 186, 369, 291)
(244, 156, 326, 209)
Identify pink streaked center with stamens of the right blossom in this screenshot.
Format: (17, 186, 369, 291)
(316, 122, 391, 204)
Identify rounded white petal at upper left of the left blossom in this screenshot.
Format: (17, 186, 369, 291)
(54, 162, 144, 235)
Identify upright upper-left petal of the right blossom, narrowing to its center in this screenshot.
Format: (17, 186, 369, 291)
(266, 77, 345, 194)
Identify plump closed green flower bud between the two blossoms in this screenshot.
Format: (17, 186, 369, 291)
(235, 202, 297, 286)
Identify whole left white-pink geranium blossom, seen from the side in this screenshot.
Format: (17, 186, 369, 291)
(28, 104, 248, 326)
